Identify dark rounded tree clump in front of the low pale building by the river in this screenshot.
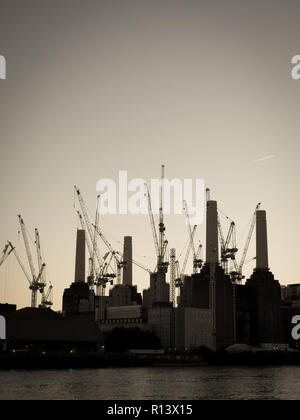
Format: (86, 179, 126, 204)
(105, 327, 161, 353)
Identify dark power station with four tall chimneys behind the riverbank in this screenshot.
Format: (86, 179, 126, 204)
(59, 185, 284, 351)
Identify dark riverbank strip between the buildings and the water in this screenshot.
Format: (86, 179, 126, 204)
(0, 352, 300, 370)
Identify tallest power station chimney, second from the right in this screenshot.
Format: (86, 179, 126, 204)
(206, 200, 219, 264)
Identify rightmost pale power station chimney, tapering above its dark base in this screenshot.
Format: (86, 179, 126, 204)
(256, 210, 269, 270)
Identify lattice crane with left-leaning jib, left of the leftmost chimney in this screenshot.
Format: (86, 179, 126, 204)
(15, 215, 46, 308)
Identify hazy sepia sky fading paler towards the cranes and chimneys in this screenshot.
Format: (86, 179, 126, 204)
(0, 0, 300, 309)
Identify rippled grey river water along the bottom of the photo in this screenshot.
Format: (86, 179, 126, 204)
(0, 366, 300, 400)
